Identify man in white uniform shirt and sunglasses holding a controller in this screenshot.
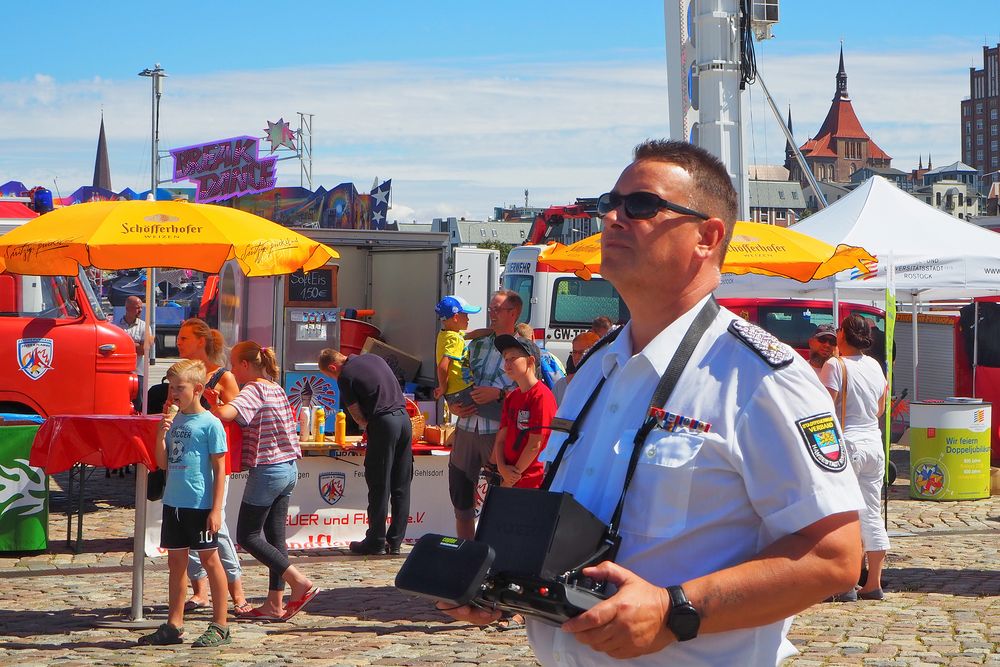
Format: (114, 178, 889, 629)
(439, 141, 862, 666)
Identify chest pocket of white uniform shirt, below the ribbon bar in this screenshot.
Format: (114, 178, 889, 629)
(622, 430, 704, 539)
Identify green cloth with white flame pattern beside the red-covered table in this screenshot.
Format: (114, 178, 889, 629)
(0, 426, 49, 551)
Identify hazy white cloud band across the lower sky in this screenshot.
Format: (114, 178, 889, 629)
(0, 41, 976, 221)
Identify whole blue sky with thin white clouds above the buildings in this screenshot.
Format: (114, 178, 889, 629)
(0, 0, 1000, 221)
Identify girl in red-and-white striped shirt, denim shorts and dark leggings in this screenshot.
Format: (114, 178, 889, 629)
(217, 341, 319, 621)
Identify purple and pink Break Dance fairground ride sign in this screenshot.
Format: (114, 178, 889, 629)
(170, 137, 278, 204)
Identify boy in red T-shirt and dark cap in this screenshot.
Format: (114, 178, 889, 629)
(493, 334, 556, 489)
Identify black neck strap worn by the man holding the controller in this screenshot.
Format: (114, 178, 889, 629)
(542, 296, 719, 560)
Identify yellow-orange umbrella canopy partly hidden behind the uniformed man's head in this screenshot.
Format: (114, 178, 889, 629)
(538, 222, 876, 282)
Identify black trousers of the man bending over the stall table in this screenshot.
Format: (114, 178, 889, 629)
(365, 410, 413, 548)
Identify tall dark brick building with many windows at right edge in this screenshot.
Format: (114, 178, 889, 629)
(961, 44, 1000, 192)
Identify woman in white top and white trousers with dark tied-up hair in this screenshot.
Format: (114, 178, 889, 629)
(820, 314, 889, 600)
